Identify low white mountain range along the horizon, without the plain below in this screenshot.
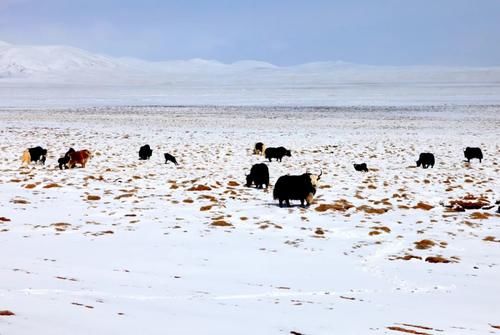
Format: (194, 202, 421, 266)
(0, 41, 500, 86)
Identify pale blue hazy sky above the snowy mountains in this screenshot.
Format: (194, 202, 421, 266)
(0, 0, 500, 66)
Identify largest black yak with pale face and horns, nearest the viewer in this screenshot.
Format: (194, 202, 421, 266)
(273, 172, 323, 207)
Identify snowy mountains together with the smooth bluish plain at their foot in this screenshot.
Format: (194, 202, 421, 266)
(0, 42, 500, 106)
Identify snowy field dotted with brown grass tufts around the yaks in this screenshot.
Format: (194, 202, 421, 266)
(0, 106, 500, 335)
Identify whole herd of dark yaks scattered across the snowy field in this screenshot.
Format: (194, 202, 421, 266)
(22, 142, 483, 207)
